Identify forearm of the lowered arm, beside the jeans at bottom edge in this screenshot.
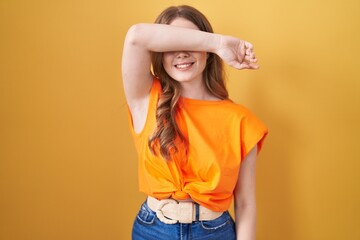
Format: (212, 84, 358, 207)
(235, 204, 256, 240)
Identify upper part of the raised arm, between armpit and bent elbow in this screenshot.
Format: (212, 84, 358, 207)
(122, 25, 153, 110)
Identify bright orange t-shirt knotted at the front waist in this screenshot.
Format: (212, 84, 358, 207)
(128, 78, 268, 211)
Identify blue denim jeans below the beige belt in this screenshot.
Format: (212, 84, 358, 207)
(132, 202, 236, 240)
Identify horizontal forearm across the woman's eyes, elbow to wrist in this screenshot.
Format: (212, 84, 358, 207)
(126, 23, 221, 52)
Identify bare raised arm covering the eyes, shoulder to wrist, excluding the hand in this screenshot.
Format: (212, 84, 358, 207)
(122, 23, 220, 106)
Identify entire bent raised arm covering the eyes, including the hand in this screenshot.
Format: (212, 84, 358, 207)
(122, 23, 257, 108)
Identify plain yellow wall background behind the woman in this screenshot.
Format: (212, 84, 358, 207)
(0, 0, 360, 240)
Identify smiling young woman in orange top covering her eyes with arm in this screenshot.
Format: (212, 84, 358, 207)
(122, 6, 267, 240)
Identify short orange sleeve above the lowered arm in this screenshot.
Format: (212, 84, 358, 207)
(240, 110, 268, 160)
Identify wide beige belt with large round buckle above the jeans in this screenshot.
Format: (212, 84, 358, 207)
(147, 196, 223, 224)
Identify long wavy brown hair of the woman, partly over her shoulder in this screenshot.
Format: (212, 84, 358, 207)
(148, 5, 228, 160)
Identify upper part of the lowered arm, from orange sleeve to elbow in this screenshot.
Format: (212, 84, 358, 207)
(234, 145, 257, 208)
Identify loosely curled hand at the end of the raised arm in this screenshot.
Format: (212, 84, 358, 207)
(215, 36, 259, 70)
